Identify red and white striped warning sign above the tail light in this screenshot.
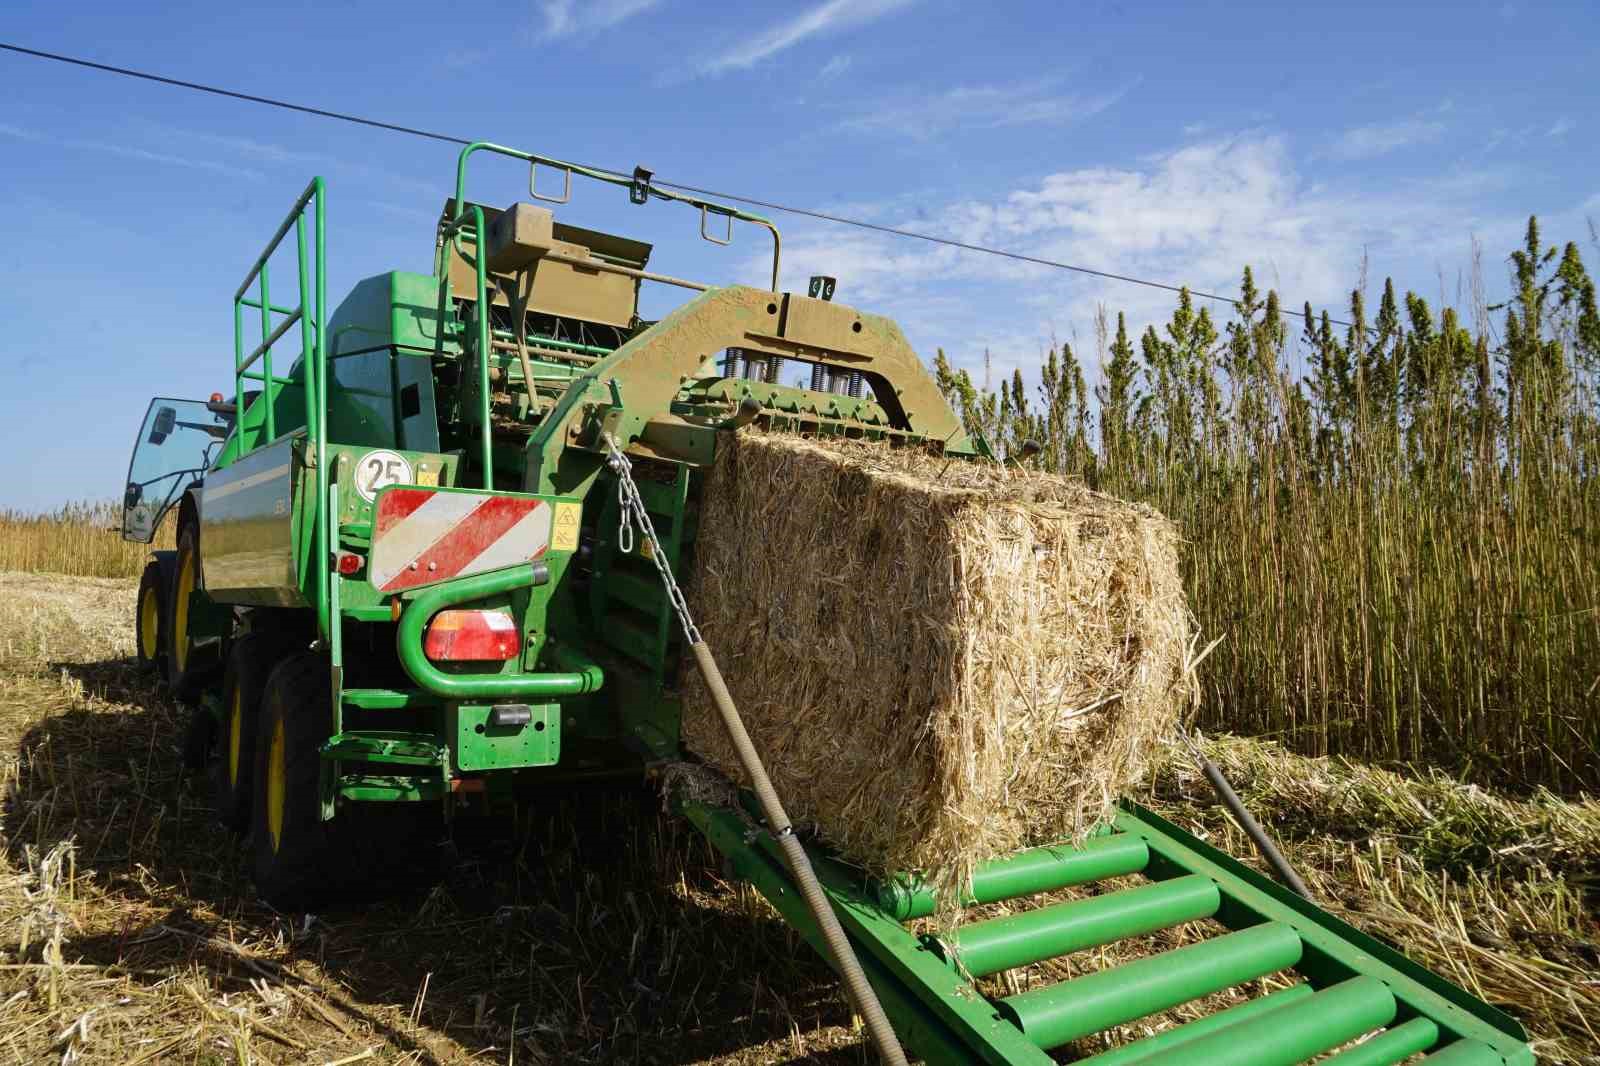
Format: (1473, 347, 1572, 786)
(366, 488, 550, 592)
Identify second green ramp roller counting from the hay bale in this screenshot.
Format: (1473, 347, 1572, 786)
(938, 874, 1222, 976)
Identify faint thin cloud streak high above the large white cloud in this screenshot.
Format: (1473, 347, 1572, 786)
(838, 80, 1138, 138)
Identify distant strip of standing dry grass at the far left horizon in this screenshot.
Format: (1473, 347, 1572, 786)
(0, 503, 173, 578)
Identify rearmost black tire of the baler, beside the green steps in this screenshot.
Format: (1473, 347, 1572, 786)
(251, 651, 442, 911)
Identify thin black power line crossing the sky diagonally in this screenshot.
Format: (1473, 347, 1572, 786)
(0, 42, 1350, 327)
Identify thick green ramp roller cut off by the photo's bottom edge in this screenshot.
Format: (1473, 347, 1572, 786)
(1139, 976, 1395, 1066)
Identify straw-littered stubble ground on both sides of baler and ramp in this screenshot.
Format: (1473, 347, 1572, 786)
(0, 573, 1600, 1066)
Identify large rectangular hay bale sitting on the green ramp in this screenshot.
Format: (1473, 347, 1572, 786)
(683, 431, 1190, 887)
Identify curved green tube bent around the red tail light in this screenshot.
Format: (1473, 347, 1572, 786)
(395, 563, 605, 699)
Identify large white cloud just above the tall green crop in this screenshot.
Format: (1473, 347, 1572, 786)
(746, 131, 1515, 384)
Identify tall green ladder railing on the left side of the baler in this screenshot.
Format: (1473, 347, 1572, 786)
(234, 178, 330, 637)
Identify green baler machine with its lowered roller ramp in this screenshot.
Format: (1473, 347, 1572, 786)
(123, 142, 1533, 1066)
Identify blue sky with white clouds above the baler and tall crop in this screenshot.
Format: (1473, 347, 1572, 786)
(0, 0, 1600, 509)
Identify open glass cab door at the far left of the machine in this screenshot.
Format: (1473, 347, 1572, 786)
(122, 397, 232, 544)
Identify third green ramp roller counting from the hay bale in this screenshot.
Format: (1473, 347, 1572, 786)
(997, 922, 1302, 1061)
